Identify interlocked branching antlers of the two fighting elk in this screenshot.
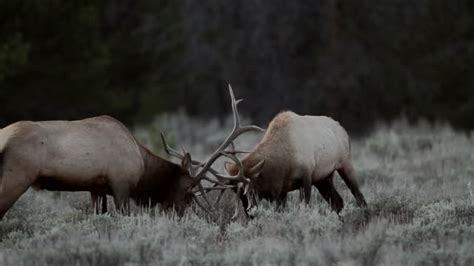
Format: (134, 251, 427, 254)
(161, 85, 265, 218)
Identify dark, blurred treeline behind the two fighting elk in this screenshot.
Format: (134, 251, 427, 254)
(0, 0, 474, 132)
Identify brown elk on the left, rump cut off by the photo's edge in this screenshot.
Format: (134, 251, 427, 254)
(0, 87, 259, 219)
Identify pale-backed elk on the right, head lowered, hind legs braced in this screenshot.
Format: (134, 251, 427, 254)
(225, 111, 367, 213)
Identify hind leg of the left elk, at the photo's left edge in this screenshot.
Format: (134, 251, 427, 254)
(0, 172, 32, 220)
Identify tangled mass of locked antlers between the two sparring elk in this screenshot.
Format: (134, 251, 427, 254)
(161, 85, 264, 218)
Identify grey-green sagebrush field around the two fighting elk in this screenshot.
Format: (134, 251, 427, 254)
(0, 115, 474, 265)
